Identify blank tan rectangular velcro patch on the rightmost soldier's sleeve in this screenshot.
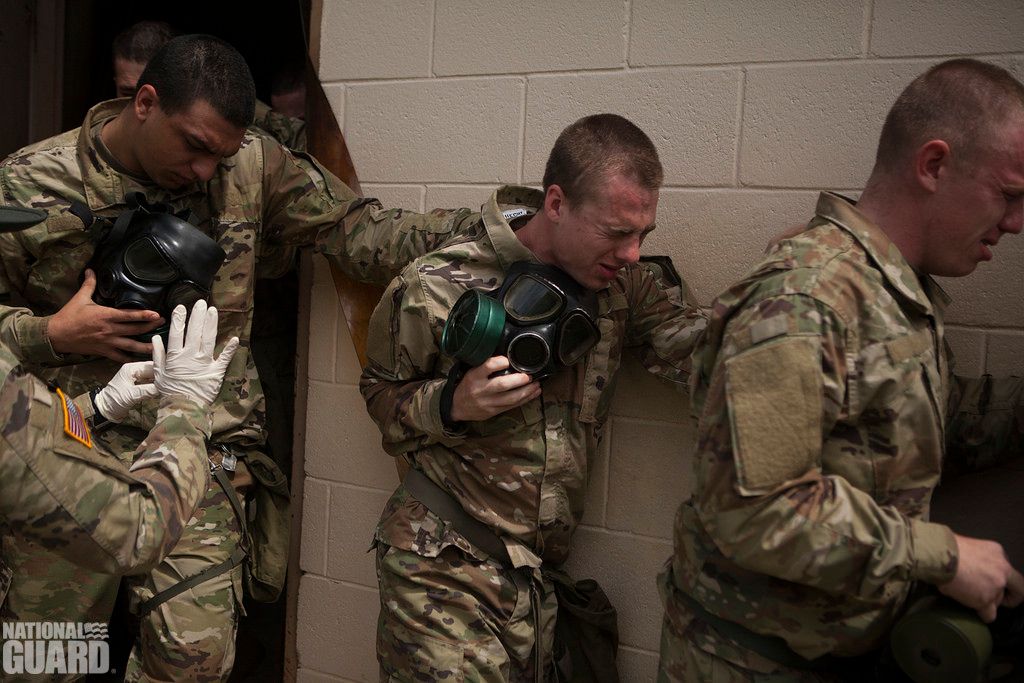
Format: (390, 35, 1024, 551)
(725, 337, 823, 496)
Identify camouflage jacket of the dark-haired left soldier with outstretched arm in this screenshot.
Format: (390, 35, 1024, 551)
(0, 100, 470, 453)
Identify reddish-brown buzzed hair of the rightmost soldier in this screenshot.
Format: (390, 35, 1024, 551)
(876, 58, 1024, 171)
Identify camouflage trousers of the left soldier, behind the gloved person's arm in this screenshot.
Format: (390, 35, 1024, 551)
(2, 448, 242, 681)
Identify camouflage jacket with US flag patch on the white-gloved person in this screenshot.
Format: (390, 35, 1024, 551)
(0, 337, 210, 581)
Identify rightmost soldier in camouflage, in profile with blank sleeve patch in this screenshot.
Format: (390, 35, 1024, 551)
(658, 59, 1024, 681)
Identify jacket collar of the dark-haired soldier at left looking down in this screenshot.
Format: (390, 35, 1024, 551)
(78, 97, 200, 211)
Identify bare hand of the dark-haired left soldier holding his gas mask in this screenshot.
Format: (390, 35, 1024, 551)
(46, 268, 164, 362)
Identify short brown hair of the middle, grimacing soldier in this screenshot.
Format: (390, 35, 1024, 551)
(544, 114, 665, 204)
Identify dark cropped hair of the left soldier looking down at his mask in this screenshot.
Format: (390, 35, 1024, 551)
(138, 34, 256, 128)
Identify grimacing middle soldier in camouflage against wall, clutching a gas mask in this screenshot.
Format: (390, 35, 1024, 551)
(360, 115, 705, 681)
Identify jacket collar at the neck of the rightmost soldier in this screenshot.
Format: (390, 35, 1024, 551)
(814, 193, 948, 314)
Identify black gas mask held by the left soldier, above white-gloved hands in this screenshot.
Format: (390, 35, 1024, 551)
(72, 193, 226, 342)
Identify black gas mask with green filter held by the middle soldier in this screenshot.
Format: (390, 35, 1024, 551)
(441, 261, 601, 380)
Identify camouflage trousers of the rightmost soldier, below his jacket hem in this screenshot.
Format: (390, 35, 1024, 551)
(657, 563, 844, 683)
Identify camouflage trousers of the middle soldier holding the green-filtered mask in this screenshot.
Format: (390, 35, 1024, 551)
(377, 544, 557, 683)
